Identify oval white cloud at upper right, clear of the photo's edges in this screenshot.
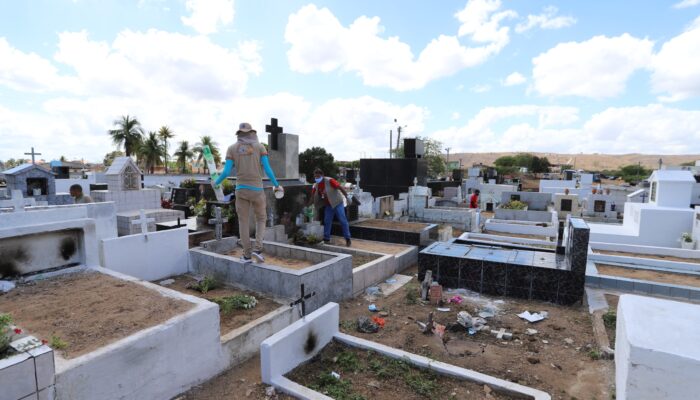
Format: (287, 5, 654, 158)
(532, 33, 654, 99)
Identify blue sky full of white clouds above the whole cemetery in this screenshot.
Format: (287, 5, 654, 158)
(0, 0, 700, 161)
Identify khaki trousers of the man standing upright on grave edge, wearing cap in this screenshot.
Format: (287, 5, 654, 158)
(236, 189, 267, 258)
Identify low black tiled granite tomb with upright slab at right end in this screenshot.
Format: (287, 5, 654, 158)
(418, 218, 590, 305)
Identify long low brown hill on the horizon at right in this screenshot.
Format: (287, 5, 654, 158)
(450, 152, 700, 170)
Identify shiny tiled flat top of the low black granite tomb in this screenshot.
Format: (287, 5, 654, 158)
(421, 242, 571, 270)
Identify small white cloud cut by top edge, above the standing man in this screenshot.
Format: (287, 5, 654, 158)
(181, 0, 234, 35)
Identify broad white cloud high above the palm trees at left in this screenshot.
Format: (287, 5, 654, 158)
(55, 29, 262, 99)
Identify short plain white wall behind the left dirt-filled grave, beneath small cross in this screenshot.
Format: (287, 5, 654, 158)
(101, 228, 189, 281)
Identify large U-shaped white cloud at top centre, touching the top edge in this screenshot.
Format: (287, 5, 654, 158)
(285, 0, 513, 91)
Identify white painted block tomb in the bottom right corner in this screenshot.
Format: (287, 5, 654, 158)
(615, 295, 700, 400)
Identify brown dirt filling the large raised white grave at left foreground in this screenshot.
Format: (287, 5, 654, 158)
(0, 272, 194, 359)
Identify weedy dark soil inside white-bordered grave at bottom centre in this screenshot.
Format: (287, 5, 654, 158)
(287, 341, 512, 400)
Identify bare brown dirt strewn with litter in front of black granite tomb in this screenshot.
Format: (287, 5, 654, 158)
(340, 278, 614, 400)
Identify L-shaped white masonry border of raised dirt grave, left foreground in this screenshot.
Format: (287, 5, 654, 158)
(56, 268, 226, 400)
